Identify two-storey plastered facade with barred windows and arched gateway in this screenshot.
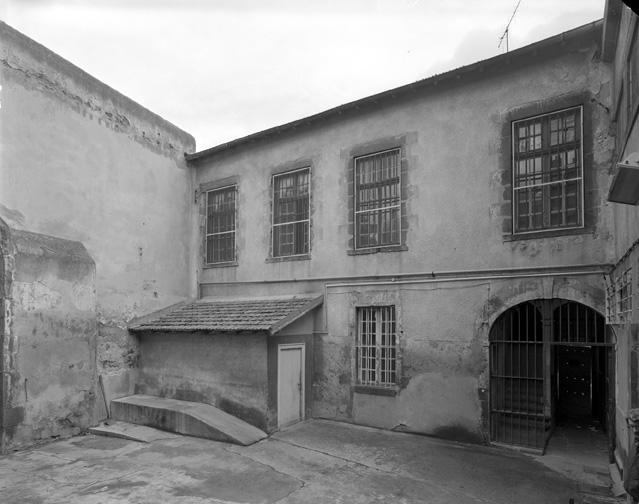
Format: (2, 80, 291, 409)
(187, 22, 614, 448)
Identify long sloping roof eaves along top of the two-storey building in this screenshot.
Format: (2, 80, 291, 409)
(185, 18, 604, 164)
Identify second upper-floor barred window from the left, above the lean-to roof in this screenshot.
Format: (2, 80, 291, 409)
(273, 168, 311, 257)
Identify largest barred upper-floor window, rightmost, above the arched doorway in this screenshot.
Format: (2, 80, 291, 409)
(512, 106, 583, 233)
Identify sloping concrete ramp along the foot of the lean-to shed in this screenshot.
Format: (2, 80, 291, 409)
(111, 394, 267, 446)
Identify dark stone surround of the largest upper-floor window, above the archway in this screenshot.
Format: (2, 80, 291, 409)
(500, 92, 599, 242)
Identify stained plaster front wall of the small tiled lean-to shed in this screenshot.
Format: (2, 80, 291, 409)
(136, 332, 269, 429)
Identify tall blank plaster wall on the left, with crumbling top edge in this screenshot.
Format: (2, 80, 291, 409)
(0, 23, 195, 398)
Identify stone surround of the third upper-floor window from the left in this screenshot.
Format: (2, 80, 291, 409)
(346, 135, 408, 255)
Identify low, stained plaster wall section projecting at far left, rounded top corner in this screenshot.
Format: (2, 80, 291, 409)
(4, 230, 97, 448)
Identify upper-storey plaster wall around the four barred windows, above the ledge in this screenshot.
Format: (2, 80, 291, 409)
(196, 29, 614, 294)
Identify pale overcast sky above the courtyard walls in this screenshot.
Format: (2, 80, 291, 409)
(0, 0, 604, 150)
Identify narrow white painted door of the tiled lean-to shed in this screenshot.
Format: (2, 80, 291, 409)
(277, 344, 304, 428)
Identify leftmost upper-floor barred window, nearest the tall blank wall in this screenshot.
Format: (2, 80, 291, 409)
(206, 185, 237, 264)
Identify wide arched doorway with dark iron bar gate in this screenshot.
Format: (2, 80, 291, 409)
(489, 299, 614, 451)
